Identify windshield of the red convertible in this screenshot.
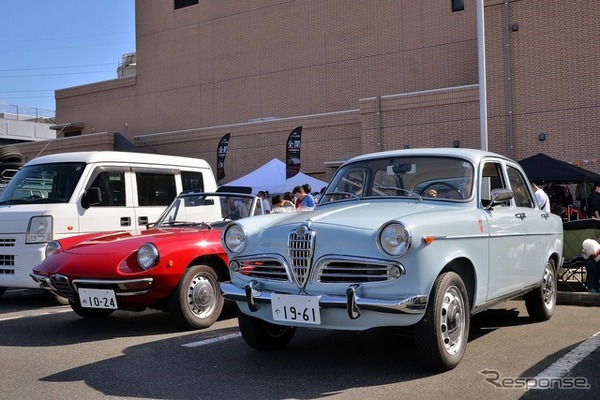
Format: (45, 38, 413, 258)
(155, 193, 262, 226)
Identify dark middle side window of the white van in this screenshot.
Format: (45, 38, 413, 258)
(135, 172, 177, 206)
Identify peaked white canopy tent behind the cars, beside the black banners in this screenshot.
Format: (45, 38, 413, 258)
(224, 158, 327, 195)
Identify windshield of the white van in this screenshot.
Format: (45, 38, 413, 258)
(0, 163, 85, 204)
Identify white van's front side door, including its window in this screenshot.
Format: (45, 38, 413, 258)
(79, 167, 137, 233)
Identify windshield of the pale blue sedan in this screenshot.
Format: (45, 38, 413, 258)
(319, 156, 473, 203)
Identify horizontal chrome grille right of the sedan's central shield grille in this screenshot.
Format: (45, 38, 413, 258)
(318, 259, 404, 283)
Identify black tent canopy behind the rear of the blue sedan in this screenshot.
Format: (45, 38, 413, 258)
(519, 153, 600, 183)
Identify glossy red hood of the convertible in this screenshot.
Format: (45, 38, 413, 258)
(61, 228, 220, 255)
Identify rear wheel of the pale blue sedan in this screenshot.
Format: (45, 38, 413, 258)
(524, 259, 558, 322)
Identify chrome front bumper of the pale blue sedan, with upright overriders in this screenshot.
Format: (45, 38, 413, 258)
(221, 280, 427, 319)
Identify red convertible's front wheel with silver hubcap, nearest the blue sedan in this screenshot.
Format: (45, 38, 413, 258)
(168, 265, 225, 329)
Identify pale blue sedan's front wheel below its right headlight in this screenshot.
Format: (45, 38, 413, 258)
(414, 272, 471, 371)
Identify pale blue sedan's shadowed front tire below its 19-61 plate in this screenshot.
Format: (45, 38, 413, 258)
(238, 310, 296, 351)
